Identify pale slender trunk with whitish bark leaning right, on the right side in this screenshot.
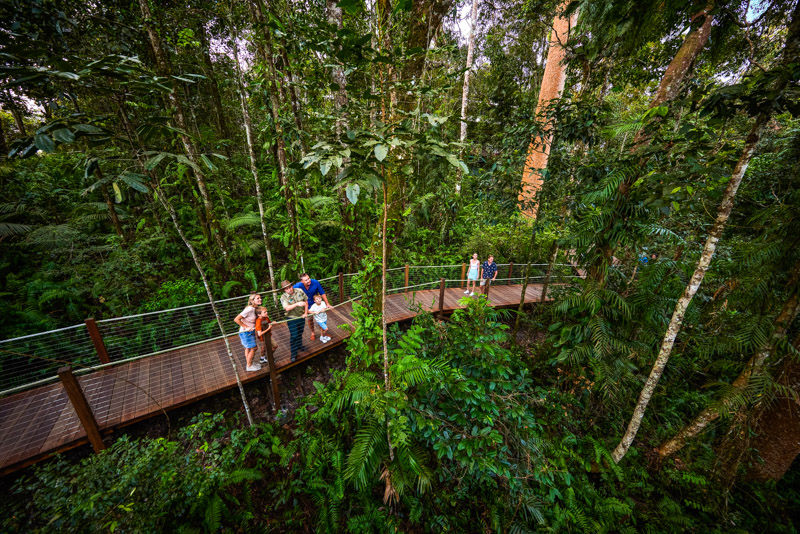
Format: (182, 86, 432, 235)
(612, 114, 768, 462)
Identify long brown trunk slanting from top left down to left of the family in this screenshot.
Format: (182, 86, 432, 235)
(139, 0, 231, 272)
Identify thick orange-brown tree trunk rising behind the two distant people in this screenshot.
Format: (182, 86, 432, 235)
(519, 0, 578, 219)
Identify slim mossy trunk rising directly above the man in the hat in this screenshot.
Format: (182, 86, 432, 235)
(250, 0, 303, 265)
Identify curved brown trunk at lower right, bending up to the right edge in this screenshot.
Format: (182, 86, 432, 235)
(658, 262, 800, 458)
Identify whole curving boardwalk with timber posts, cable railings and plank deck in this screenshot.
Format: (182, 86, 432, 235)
(0, 263, 580, 472)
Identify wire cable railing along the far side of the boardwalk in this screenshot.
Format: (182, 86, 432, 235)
(0, 264, 578, 396)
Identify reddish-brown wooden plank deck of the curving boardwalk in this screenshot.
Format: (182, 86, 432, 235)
(0, 284, 542, 475)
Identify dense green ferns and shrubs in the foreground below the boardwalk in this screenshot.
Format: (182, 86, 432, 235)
(2, 300, 800, 533)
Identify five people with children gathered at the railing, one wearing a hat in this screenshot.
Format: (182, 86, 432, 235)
(234, 273, 331, 372)
